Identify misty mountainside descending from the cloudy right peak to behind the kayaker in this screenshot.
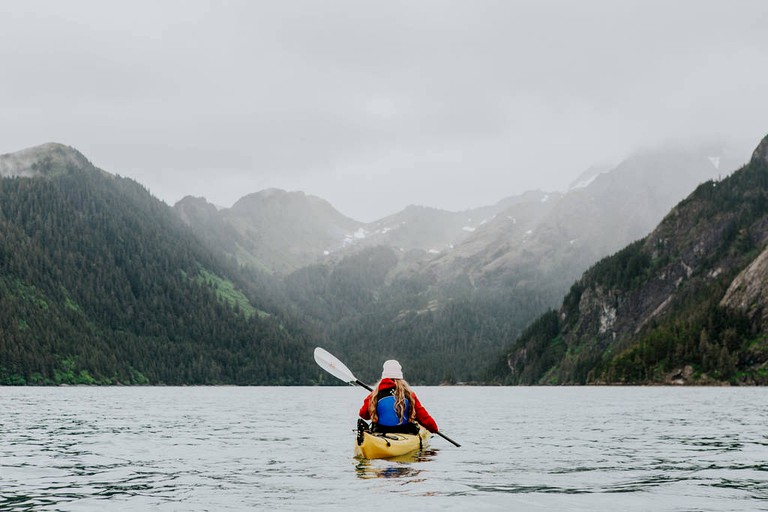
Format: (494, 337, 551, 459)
(278, 142, 729, 384)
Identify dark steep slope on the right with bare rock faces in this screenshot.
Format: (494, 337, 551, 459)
(496, 137, 768, 384)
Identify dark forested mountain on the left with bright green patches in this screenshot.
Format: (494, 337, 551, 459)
(0, 144, 318, 384)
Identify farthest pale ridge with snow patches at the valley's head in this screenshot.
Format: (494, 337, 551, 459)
(174, 189, 515, 275)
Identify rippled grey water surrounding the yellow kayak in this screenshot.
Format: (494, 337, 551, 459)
(0, 387, 768, 512)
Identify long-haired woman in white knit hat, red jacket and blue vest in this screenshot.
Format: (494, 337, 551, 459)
(359, 359, 438, 434)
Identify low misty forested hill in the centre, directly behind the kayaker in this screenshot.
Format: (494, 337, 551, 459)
(285, 247, 546, 384)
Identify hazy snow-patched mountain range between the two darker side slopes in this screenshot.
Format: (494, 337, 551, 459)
(170, 141, 728, 384)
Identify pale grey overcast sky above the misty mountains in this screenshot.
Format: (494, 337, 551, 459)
(0, 0, 768, 221)
